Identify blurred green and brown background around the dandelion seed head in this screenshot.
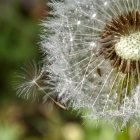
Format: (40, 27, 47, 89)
(0, 0, 140, 140)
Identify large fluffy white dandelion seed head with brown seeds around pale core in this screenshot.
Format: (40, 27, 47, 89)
(16, 0, 140, 127)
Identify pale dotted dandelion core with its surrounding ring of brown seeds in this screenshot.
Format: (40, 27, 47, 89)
(100, 10, 140, 102)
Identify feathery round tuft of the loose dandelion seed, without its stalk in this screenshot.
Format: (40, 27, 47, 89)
(16, 61, 42, 100)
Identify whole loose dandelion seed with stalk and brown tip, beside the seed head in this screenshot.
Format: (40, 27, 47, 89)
(16, 61, 66, 109)
